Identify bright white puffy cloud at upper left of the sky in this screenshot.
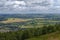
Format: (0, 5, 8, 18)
(5, 1, 26, 8)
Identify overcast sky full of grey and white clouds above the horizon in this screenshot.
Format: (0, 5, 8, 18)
(0, 0, 60, 13)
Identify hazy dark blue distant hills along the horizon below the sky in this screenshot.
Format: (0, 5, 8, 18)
(0, 14, 60, 21)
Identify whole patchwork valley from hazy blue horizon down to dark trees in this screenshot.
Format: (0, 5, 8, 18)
(0, 14, 60, 29)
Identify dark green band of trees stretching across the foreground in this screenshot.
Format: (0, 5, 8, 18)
(0, 24, 60, 40)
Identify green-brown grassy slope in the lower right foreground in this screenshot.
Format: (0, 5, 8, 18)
(26, 32, 60, 40)
